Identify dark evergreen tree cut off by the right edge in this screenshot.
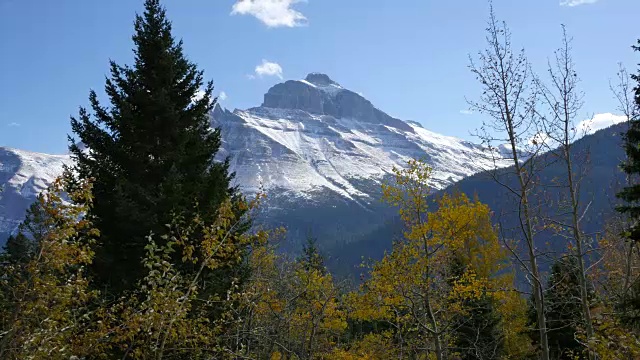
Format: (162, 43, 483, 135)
(617, 39, 640, 241)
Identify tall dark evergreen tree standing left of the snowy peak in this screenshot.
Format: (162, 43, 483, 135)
(68, 0, 240, 293)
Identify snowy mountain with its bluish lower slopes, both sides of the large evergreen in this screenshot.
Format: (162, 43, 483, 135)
(0, 73, 508, 246)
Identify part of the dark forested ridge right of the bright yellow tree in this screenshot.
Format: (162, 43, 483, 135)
(450, 123, 627, 258)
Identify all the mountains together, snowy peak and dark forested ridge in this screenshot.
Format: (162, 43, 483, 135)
(0, 73, 624, 274)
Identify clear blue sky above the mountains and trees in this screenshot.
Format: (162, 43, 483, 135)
(0, 0, 640, 153)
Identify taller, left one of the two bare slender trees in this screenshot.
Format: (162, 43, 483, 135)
(470, 6, 549, 360)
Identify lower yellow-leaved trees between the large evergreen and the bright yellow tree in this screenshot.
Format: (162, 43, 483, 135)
(232, 236, 347, 359)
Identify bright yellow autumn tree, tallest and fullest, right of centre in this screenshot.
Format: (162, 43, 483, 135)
(348, 160, 526, 359)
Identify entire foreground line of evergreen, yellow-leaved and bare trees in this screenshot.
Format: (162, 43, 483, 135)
(0, 0, 640, 360)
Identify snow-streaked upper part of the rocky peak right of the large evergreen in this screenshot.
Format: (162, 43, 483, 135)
(213, 74, 508, 205)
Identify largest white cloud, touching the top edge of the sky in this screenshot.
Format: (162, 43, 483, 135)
(231, 0, 307, 27)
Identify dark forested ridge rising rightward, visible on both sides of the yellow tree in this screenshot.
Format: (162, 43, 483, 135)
(330, 124, 626, 274)
